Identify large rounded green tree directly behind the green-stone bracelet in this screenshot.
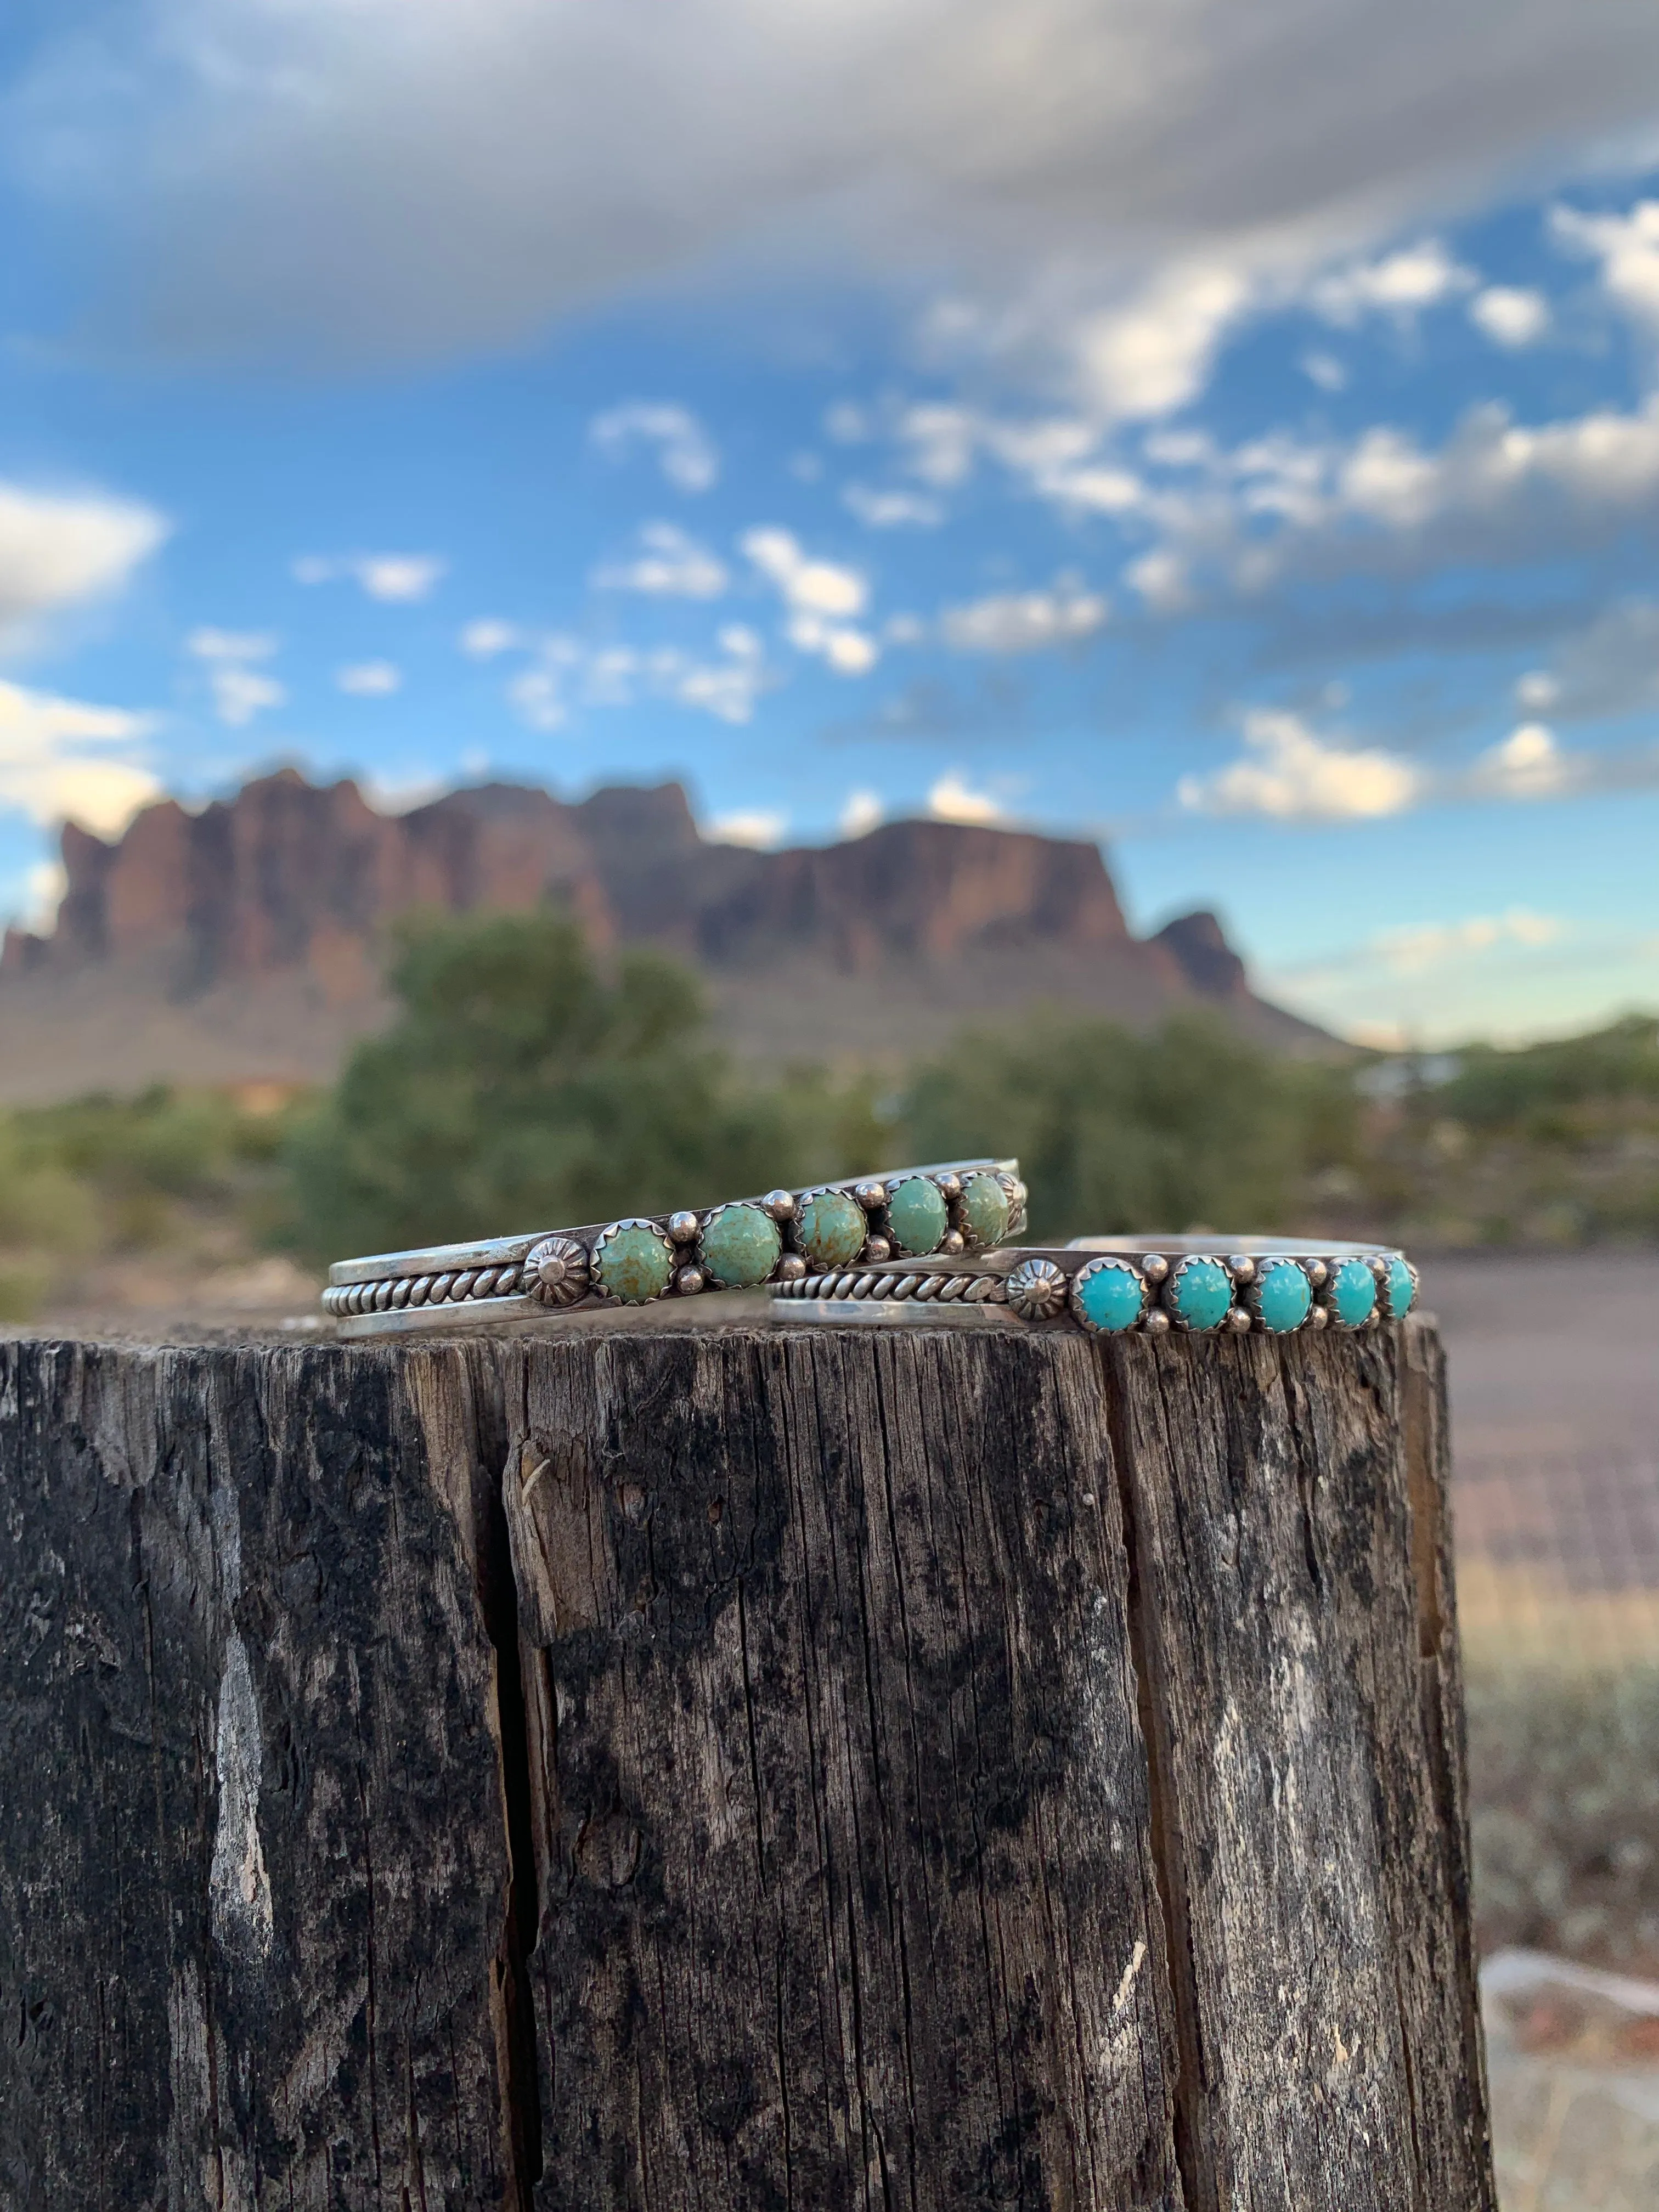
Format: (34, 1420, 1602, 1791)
(287, 916, 884, 1259)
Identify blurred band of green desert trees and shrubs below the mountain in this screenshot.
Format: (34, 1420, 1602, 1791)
(0, 916, 1659, 1318)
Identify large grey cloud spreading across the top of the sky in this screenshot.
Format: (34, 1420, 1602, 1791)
(19, 0, 1659, 376)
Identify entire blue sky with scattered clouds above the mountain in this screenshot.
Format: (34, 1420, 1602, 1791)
(0, 0, 1659, 1042)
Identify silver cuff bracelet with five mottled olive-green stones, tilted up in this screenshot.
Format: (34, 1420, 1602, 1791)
(323, 1159, 1026, 1336)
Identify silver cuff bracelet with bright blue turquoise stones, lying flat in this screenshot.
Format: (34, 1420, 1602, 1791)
(772, 1237, 1418, 1336)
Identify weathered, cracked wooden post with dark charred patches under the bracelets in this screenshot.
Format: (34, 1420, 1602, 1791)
(0, 1321, 1493, 2212)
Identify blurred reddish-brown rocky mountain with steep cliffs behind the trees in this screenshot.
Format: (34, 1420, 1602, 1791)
(0, 770, 1321, 1099)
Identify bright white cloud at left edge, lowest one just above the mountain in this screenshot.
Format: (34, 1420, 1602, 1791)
(0, 681, 159, 836)
